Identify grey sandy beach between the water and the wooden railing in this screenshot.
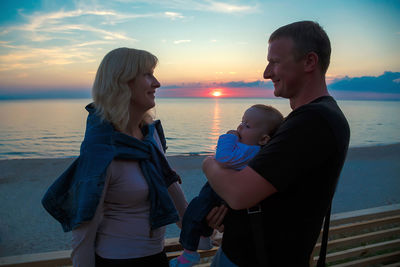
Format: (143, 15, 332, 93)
(0, 144, 400, 257)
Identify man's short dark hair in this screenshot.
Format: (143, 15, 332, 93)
(268, 21, 331, 74)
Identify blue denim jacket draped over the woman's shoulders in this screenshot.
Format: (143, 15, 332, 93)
(42, 104, 179, 232)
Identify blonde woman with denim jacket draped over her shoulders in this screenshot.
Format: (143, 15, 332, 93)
(42, 48, 187, 267)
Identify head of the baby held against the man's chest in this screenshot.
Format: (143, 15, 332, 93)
(237, 104, 283, 146)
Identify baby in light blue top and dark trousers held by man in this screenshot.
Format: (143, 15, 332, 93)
(170, 104, 283, 267)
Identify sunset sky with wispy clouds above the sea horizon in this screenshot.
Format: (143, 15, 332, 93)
(0, 0, 400, 99)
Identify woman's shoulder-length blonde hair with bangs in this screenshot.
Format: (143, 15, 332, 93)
(92, 47, 158, 131)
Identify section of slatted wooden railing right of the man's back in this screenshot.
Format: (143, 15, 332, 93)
(310, 204, 400, 267)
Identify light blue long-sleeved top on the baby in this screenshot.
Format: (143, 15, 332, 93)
(215, 133, 260, 169)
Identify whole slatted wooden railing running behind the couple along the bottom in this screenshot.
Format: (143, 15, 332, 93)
(0, 204, 400, 267)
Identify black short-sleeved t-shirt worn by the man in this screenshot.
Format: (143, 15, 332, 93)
(222, 96, 350, 266)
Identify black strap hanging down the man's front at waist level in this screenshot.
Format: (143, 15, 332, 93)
(247, 205, 267, 266)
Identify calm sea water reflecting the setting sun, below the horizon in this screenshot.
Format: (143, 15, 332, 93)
(0, 98, 400, 159)
